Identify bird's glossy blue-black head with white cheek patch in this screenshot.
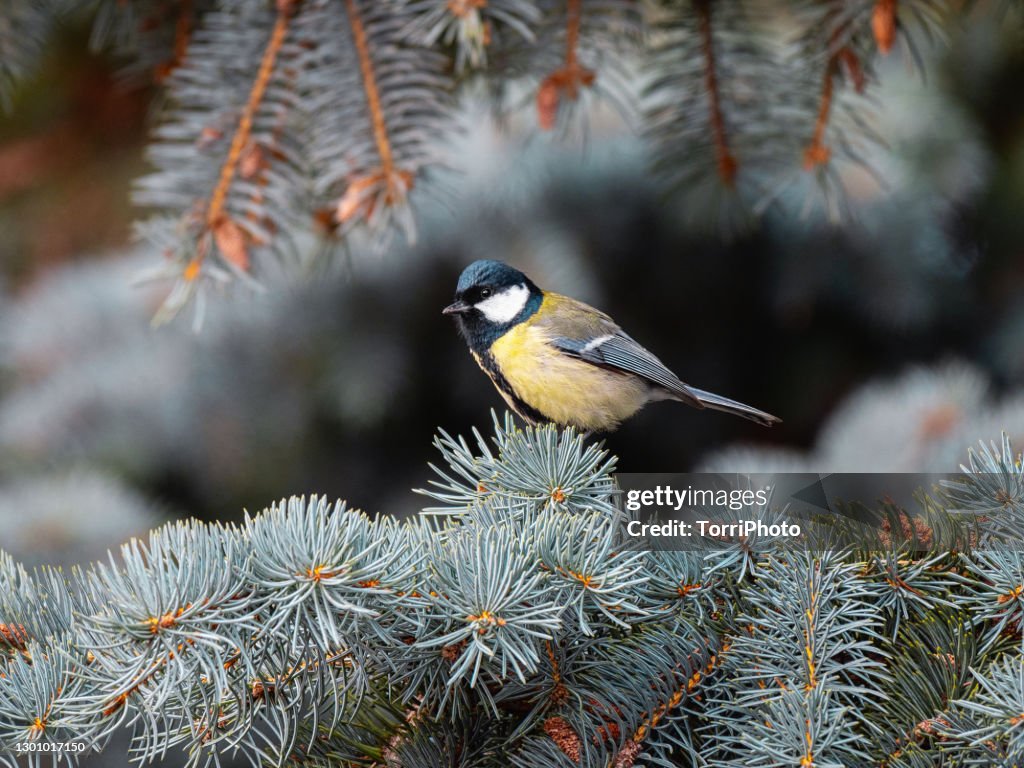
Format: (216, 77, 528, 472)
(444, 259, 544, 346)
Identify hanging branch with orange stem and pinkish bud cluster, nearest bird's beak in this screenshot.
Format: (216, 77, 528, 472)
(305, 0, 455, 249)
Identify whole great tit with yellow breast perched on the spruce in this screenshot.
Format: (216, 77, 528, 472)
(443, 260, 781, 432)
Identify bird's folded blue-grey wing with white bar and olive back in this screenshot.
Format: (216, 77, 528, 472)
(537, 294, 703, 408)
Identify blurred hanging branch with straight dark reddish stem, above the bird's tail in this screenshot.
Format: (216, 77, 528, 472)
(644, 0, 778, 222)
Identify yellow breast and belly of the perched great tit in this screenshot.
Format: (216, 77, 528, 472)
(490, 309, 650, 432)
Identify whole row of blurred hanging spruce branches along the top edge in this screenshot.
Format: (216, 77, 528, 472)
(0, 0, 996, 322)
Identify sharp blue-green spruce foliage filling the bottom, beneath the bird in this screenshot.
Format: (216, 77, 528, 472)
(0, 417, 1024, 768)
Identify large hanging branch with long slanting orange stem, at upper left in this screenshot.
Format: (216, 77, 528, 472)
(135, 0, 315, 322)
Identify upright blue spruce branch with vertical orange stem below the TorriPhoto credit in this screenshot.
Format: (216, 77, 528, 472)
(703, 553, 886, 766)
